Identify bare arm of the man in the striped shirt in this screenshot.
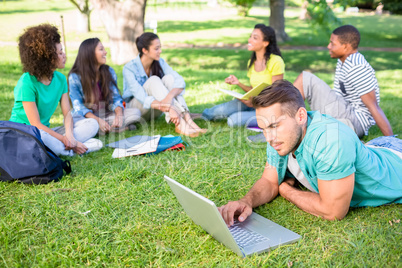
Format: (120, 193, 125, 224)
(361, 90, 393, 136)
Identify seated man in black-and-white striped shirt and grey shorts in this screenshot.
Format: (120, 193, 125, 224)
(293, 25, 393, 138)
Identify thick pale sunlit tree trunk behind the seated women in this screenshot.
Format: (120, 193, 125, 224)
(91, 0, 147, 65)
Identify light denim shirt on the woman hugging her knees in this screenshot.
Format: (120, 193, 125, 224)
(123, 55, 186, 109)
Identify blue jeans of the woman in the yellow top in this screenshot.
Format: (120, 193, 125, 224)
(202, 99, 257, 127)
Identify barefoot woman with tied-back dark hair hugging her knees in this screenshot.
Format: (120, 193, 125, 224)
(123, 32, 206, 137)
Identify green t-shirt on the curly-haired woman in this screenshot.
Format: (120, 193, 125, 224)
(10, 71, 68, 127)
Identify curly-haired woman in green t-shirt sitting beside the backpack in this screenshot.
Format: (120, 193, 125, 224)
(10, 24, 103, 156)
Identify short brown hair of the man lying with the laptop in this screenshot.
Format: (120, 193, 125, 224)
(252, 80, 306, 117)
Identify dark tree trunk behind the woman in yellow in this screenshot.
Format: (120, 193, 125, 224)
(269, 0, 290, 42)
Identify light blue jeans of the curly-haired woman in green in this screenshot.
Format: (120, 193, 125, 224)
(39, 116, 101, 156)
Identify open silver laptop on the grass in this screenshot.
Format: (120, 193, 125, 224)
(164, 176, 300, 257)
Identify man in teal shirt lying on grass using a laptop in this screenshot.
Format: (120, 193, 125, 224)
(219, 80, 402, 225)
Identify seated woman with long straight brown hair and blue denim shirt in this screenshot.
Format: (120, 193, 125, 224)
(68, 38, 141, 134)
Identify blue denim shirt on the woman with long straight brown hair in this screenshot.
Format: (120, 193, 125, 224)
(68, 67, 124, 116)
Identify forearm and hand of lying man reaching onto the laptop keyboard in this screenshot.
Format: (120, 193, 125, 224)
(219, 162, 279, 226)
